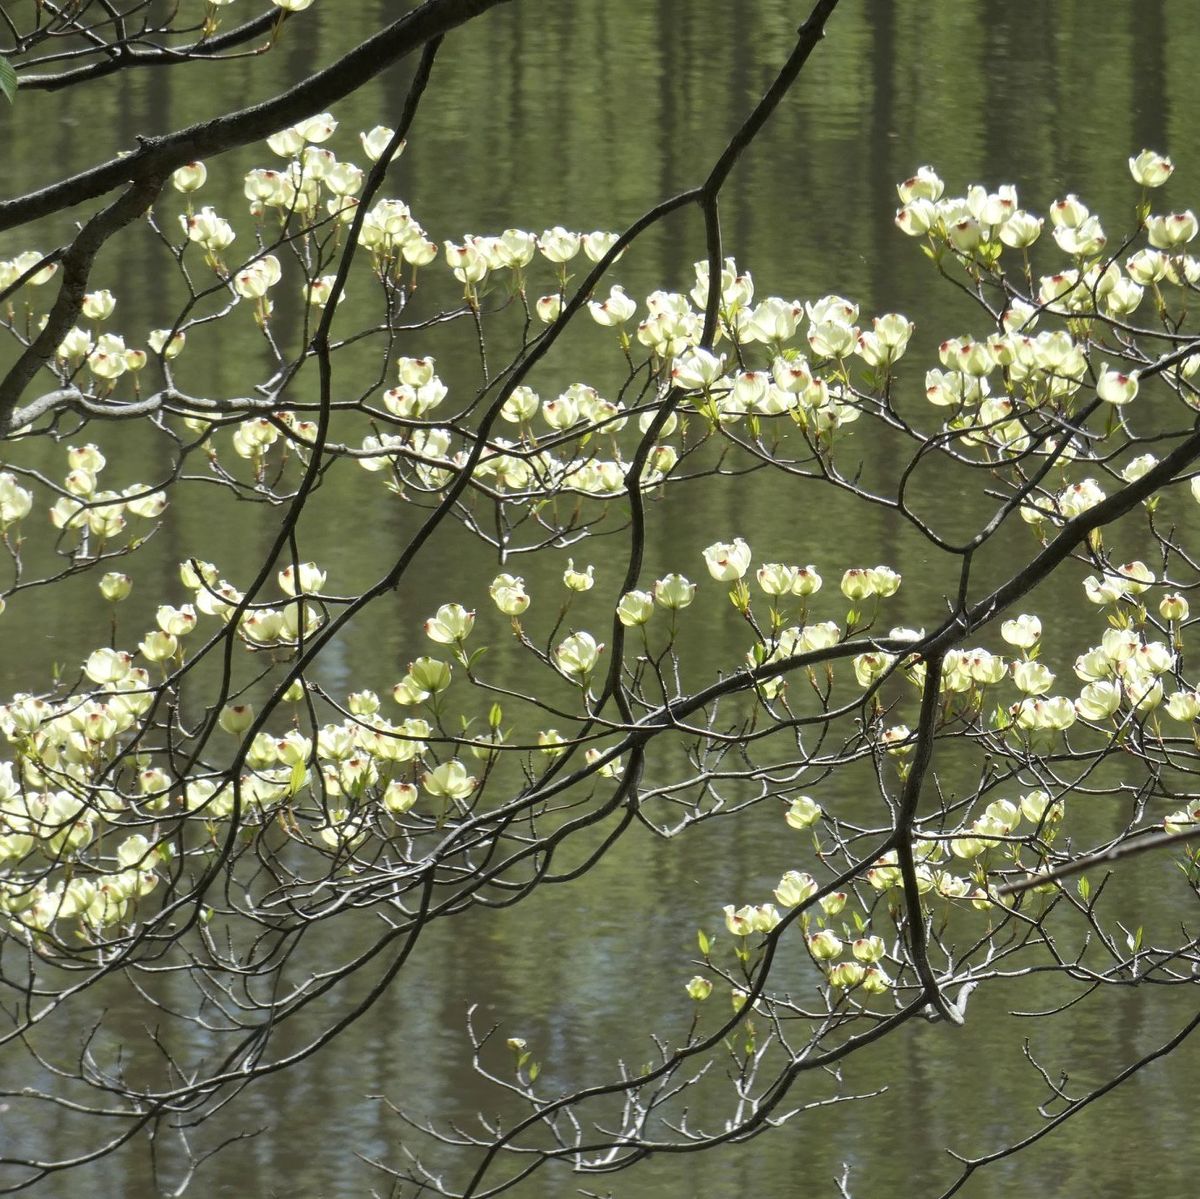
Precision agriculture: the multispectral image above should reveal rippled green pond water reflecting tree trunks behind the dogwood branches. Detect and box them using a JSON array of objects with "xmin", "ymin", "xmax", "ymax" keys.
[{"xmin": 0, "ymin": 0, "xmax": 1200, "ymax": 1199}]
